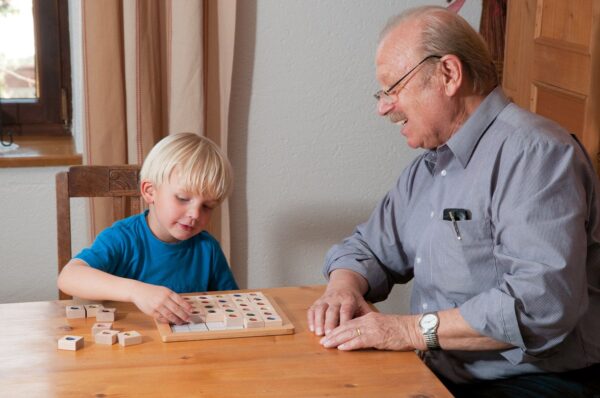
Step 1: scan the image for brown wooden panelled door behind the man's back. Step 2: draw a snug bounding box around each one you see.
[502,0,600,174]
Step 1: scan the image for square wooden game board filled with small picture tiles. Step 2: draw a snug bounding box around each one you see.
[155,291,294,343]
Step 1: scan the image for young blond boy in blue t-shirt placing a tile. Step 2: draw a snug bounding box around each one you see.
[58,133,238,324]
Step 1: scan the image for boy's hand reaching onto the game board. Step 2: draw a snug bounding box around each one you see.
[131,282,192,325]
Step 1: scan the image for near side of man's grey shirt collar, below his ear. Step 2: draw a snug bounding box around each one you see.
[446,86,510,168]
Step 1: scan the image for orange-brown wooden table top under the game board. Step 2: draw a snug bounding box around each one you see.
[0,286,451,398]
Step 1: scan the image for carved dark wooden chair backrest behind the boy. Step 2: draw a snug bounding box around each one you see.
[56,165,141,300]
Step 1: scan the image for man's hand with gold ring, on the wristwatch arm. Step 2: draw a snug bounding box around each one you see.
[320,312,424,351]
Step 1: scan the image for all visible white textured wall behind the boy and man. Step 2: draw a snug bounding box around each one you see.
[0,0,481,312]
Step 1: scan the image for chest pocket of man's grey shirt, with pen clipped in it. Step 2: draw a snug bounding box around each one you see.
[430,219,497,305]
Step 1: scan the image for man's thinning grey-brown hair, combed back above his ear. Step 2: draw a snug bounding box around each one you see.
[380,6,499,95]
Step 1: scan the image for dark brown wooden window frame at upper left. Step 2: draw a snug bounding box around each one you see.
[0,0,72,136]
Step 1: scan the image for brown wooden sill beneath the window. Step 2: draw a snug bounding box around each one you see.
[0,136,82,168]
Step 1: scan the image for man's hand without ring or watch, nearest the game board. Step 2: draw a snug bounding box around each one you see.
[307,269,373,336]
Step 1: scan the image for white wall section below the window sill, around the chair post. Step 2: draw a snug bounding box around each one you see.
[0,167,87,303]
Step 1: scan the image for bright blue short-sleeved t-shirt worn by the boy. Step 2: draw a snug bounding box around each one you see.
[75,210,238,293]
